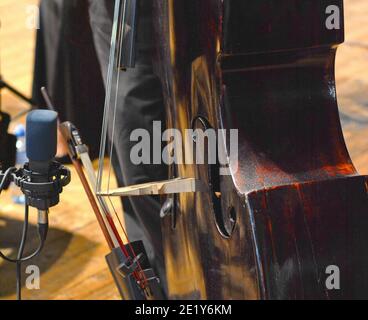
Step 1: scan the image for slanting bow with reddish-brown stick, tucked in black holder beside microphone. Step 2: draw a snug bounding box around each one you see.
[41,88,160,299]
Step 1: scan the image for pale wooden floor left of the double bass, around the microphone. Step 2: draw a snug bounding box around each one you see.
[0,0,119,299]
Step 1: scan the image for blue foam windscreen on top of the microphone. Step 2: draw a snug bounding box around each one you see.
[26,110,58,161]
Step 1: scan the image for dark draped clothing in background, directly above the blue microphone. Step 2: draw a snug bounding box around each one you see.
[33,0,105,158]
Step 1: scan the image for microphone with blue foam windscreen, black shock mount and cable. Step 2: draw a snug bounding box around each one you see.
[0,110,71,299]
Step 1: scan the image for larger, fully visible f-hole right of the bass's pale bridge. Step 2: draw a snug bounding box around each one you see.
[192,116,236,238]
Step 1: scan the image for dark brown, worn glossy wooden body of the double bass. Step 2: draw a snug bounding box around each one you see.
[154,0,368,299]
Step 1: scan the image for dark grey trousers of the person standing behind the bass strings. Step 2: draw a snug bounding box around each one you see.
[89,0,167,294]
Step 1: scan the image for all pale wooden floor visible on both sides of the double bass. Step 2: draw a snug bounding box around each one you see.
[0,0,368,299]
